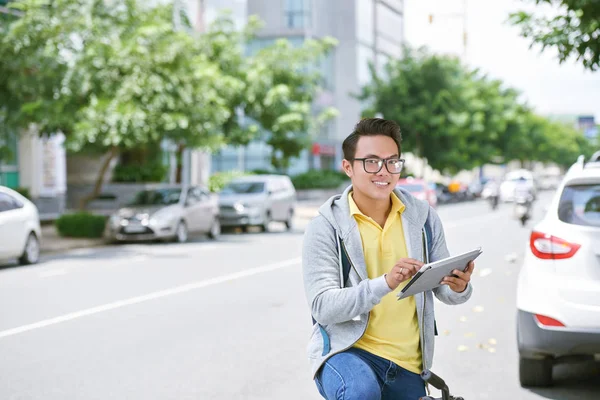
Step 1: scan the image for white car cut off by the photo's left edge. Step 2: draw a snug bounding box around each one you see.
[0,186,42,265]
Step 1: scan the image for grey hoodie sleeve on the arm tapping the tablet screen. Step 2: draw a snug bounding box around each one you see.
[302,216,392,325]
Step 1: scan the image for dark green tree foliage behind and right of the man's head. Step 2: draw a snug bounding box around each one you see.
[359,49,591,173]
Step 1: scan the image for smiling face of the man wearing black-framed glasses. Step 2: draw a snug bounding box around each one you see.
[342,135,400,200]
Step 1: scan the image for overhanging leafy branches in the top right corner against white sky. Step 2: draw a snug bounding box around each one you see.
[509,0,600,71]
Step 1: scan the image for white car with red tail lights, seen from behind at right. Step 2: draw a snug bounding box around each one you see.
[517,152,600,386]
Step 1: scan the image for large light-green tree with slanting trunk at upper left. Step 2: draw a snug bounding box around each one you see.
[0,0,234,207]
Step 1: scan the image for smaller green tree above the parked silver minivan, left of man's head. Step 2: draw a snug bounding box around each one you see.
[200,14,336,169]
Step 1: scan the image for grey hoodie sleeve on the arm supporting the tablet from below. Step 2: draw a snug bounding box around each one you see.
[428,207,473,305]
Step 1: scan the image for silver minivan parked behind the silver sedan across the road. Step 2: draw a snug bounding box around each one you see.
[219,175,296,231]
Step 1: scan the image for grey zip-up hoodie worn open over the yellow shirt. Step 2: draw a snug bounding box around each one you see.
[302,186,473,376]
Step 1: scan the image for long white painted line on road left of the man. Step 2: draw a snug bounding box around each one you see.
[0,257,302,339]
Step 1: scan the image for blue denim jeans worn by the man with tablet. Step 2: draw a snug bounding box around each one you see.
[315,348,425,400]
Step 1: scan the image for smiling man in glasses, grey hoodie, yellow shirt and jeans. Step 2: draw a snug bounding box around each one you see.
[303,118,474,400]
